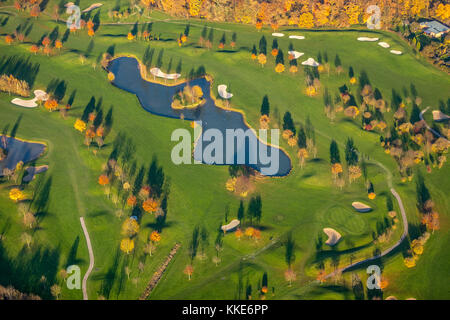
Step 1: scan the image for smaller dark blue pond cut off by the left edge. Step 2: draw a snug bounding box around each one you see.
[0,135,45,176]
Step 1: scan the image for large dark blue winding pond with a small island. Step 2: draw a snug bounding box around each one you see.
[108,57,291,176]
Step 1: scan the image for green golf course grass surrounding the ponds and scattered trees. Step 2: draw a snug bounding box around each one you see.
[0,1,450,299]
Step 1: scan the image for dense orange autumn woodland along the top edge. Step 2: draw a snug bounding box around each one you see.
[149,0,450,30]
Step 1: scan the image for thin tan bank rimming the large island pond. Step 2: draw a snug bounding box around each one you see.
[103,53,294,178]
